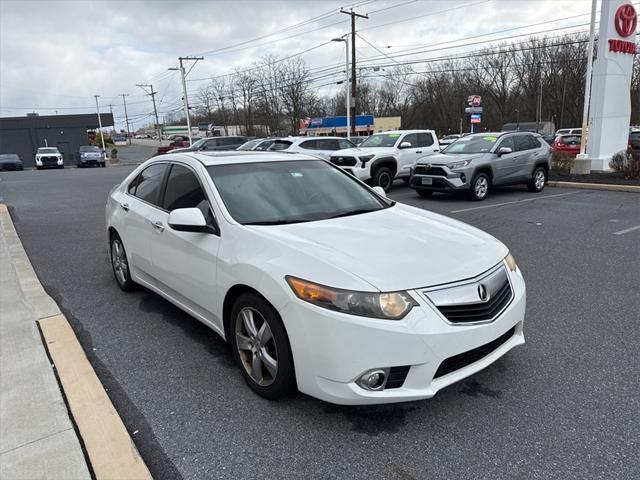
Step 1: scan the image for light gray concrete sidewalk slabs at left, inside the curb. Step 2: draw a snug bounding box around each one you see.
[0,212,91,480]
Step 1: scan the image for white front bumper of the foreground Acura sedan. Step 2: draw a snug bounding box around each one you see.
[280,264,526,405]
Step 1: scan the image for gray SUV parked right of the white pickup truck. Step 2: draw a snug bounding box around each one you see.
[409,132,551,200]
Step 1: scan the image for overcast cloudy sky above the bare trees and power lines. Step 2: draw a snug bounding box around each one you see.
[0,0,591,128]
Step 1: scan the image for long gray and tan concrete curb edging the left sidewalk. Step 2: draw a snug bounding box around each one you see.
[0,204,152,480]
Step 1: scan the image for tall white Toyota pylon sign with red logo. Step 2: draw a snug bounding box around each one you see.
[587,0,638,171]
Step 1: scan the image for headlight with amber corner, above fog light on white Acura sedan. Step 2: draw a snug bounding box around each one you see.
[285,276,418,320]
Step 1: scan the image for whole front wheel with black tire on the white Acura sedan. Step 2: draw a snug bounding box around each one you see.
[230,293,295,400]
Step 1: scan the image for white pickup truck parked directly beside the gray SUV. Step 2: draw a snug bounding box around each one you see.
[330,130,440,192]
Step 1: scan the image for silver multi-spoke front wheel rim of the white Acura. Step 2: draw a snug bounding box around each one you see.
[236,307,278,387]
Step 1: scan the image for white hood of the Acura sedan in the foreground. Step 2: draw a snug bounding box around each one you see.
[247,204,508,292]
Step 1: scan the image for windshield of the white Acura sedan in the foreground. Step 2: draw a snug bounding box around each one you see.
[207,160,395,225]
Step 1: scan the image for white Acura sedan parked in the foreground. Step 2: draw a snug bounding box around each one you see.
[106,152,525,404]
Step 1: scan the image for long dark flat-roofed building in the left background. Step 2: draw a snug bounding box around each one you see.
[0,113,113,168]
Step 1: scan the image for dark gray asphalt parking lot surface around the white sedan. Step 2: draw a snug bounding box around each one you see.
[0,167,640,479]
